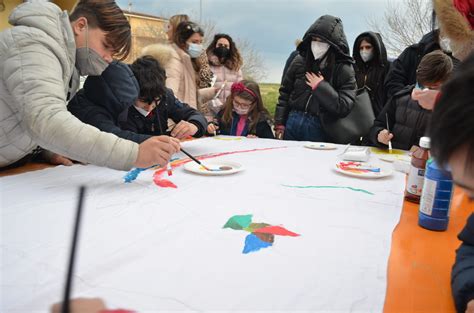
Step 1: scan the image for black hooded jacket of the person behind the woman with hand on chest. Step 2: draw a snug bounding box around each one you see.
[352,32,390,116]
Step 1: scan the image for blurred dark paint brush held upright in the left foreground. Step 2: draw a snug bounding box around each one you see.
[61,186,86,313]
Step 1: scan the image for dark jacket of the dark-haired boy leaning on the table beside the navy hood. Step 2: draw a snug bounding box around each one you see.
[118,88,207,138]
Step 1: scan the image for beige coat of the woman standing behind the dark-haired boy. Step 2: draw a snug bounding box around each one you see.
[142,44,215,114]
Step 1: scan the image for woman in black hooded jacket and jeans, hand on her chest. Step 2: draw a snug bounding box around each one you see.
[275,15,356,141]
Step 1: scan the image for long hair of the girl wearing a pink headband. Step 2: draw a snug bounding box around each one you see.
[222,80,270,132]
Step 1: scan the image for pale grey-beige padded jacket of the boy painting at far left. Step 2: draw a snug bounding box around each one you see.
[0,1,138,170]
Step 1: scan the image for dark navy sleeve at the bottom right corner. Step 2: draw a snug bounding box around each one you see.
[451,214,474,313]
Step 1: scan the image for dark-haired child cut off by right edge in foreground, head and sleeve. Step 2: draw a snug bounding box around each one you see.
[430,54,474,313]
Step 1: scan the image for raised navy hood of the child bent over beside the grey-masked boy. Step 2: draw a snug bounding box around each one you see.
[84,61,140,116]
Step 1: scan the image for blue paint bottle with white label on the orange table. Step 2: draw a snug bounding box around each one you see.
[418,159,453,231]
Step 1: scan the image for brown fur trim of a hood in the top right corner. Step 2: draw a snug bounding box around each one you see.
[433,0,474,60]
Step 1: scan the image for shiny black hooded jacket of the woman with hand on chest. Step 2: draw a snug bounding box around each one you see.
[275,15,356,125]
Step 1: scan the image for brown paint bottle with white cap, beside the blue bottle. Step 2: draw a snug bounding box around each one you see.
[405,137,430,203]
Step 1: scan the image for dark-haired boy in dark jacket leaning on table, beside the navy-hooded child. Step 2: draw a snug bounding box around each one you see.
[118,56,207,139]
